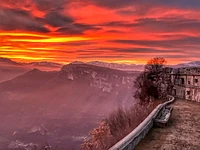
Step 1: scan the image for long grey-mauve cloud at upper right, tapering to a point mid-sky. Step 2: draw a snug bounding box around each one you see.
[100,17,200,33]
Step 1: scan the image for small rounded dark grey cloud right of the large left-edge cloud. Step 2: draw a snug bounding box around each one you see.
[45,12,74,27]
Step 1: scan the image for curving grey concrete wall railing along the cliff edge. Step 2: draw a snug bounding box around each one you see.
[109,95,175,150]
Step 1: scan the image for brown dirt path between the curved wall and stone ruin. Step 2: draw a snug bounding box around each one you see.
[135,99,200,150]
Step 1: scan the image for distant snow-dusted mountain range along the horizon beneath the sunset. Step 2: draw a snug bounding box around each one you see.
[0,58,200,82]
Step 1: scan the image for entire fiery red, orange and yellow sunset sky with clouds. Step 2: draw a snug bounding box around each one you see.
[0,0,200,64]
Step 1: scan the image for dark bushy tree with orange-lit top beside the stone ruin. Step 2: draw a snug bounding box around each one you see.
[134,57,166,104]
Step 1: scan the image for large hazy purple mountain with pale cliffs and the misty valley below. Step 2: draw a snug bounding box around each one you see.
[0,64,138,150]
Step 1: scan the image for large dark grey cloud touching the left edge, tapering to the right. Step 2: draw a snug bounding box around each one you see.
[0,9,49,32]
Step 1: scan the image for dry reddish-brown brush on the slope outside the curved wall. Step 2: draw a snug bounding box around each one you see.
[81,101,160,150]
